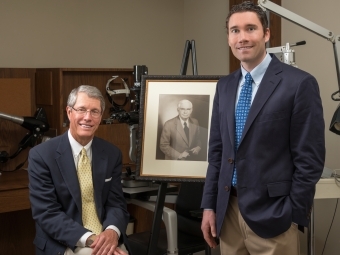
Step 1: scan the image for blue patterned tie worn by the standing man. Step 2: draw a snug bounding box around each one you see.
[232,73,253,186]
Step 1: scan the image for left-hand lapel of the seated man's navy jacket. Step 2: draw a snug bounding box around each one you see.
[55,132,82,212]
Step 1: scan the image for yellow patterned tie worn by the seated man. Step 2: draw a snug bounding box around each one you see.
[78,148,102,235]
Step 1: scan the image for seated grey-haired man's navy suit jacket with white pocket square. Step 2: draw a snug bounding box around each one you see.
[28,132,129,255]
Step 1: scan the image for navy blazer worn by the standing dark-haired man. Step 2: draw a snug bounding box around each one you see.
[202,56,325,238]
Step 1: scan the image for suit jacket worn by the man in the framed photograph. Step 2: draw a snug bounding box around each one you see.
[160,116,201,160]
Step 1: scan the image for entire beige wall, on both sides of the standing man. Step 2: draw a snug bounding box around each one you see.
[0,0,340,254]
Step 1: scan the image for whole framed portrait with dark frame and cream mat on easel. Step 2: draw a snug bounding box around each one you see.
[136,75,223,182]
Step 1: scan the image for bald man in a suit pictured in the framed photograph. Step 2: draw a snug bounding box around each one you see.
[159,99,202,160]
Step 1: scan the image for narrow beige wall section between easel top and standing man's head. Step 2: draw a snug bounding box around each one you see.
[183,0,229,75]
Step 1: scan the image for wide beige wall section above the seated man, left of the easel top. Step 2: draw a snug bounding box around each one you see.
[0,0,184,74]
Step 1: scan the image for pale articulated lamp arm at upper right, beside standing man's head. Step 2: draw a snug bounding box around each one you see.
[258,0,340,101]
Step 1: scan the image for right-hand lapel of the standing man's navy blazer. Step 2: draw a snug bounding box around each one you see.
[240,55,282,144]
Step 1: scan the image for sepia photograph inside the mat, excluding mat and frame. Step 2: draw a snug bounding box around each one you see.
[156,94,210,161]
